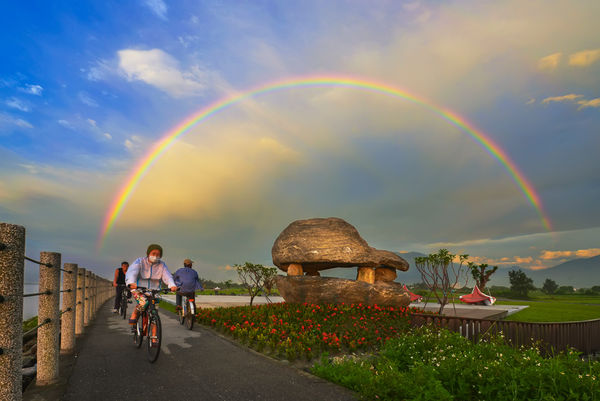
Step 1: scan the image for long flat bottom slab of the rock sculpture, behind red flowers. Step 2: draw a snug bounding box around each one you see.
[275,276,410,307]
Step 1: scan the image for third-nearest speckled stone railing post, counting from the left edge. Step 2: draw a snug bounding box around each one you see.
[60,263,77,354]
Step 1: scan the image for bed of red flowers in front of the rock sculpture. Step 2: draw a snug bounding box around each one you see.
[196,303,422,360]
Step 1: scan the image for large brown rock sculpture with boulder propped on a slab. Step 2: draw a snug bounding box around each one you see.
[271,217,410,306]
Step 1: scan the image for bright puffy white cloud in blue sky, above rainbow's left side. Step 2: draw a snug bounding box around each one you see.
[118,49,209,97]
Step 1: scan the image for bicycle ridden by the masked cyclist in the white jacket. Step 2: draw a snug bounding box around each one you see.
[133,287,166,363]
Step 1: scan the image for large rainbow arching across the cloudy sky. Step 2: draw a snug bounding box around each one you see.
[97,76,552,249]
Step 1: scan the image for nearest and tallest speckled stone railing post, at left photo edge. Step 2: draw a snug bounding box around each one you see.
[0,223,25,401]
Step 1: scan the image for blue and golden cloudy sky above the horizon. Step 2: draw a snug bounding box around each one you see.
[0,0,600,279]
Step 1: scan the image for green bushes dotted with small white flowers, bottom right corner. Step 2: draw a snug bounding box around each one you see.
[312,328,600,401]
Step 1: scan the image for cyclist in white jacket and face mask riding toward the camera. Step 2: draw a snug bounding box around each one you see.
[125,244,177,336]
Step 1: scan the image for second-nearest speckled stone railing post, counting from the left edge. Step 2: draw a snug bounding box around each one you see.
[36,252,61,386]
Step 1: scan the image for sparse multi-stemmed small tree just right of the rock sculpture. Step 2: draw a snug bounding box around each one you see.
[415,249,469,315]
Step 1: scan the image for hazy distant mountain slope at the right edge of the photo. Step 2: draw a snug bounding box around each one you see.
[525,255,600,288]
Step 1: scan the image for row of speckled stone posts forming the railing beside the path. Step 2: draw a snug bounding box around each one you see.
[0,223,114,401]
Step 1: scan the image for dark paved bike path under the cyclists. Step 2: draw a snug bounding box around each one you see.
[61,302,356,401]
